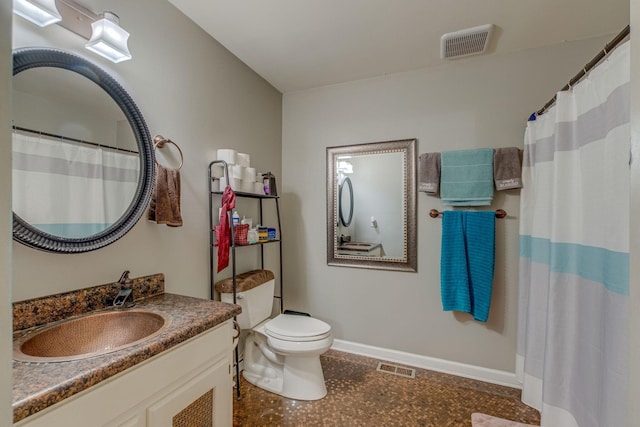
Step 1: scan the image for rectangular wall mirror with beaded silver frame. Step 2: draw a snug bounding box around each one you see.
[327,139,417,271]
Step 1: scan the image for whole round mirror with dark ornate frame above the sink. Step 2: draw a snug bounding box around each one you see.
[12,49,154,253]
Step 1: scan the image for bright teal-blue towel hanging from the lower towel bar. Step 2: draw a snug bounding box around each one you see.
[440,211,496,322]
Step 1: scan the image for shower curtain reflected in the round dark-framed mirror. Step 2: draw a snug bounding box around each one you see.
[12,132,140,238]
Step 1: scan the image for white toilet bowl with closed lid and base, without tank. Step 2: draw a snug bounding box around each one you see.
[242,314,333,400]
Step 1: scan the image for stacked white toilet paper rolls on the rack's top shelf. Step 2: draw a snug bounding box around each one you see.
[212,148,264,194]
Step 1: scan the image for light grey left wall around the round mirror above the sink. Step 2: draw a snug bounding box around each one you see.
[11,0,282,301]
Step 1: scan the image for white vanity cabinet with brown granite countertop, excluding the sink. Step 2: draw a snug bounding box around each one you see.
[13,276,241,427]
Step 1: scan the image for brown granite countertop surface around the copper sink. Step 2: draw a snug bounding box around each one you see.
[13,280,241,422]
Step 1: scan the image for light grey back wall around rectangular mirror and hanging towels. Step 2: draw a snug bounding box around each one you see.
[282,35,611,372]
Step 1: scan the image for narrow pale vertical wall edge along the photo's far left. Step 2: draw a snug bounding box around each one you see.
[0,1,13,426]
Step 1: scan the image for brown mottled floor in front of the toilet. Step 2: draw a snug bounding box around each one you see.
[233,350,540,427]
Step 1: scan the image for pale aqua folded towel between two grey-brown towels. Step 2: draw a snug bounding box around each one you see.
[440,148,493,206]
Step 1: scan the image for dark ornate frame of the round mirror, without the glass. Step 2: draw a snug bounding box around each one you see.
[13,48,154,253]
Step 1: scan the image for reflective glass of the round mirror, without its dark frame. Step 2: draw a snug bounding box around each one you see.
[12,68,140,238]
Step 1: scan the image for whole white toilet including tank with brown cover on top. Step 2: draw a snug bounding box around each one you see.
[215,270,333,400]
